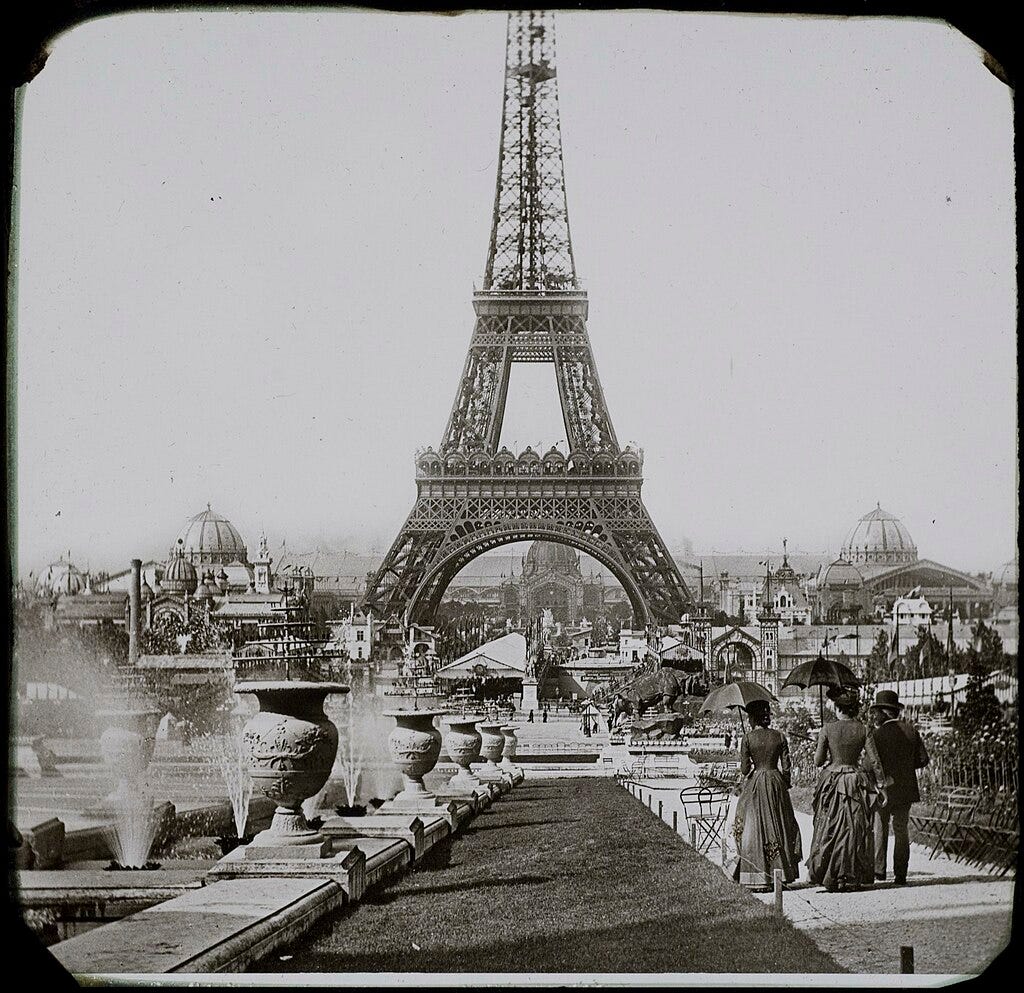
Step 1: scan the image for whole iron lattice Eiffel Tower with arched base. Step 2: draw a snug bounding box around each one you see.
[362,10,691,625]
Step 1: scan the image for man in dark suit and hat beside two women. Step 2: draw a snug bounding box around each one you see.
[867,690,928,886]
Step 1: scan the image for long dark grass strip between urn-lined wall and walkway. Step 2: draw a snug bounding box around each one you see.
[253,779,844,973]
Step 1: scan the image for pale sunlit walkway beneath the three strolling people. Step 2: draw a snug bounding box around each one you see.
[626,780,1014,976]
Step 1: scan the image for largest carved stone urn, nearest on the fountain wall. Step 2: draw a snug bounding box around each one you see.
[234,680,349,858]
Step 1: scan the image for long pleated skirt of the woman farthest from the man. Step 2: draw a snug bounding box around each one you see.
[732,769,803,890]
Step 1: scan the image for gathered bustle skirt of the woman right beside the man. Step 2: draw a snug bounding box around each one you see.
[807,766,874,891]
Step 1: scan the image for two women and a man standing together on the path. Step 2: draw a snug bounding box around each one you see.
[733,689,929,893]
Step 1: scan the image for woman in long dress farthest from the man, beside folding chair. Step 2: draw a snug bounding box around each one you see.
[732,700,803,891]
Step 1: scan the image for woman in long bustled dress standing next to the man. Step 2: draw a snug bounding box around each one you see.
[807,690,874,893]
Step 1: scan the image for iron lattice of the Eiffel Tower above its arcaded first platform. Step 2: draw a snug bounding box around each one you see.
[441,10,620,456]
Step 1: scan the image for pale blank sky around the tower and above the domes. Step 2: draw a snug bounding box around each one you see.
[16,11,1016,574]
